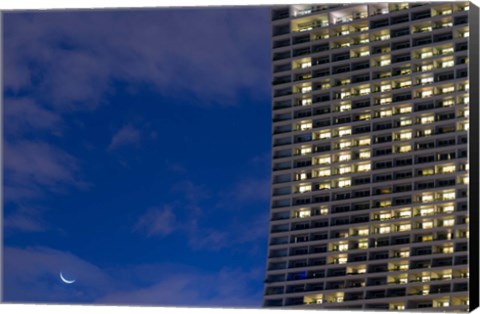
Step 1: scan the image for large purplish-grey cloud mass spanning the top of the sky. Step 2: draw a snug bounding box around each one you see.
[4,8,270,111]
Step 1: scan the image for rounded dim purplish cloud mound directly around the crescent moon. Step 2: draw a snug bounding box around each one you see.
[3,246,113,303]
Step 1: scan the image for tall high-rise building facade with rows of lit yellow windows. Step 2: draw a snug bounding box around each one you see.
[264,2,478,311]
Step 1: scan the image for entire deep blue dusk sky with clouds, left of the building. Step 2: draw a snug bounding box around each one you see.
[3,7,271,307]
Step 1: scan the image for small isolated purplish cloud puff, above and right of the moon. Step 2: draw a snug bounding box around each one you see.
[134,206,178,237]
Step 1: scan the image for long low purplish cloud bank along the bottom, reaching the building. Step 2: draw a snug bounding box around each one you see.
[4,247,263,307]
